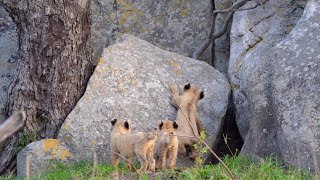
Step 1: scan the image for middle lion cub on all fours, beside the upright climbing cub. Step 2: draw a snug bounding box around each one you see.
[155,120,179,170]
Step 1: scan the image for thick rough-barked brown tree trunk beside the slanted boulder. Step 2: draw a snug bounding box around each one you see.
[0,0,94,174]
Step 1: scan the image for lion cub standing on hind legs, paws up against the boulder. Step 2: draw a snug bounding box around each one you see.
[170,83,204,156]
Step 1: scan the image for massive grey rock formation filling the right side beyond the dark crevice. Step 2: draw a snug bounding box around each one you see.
[229,0,320,172]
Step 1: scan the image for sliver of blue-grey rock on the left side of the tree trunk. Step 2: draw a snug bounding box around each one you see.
[0,6,18,123]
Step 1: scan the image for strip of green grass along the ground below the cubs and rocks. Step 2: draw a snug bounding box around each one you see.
[0,156,315,180]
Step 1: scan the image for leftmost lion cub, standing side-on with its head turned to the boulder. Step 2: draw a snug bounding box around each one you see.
[110,119,157,172]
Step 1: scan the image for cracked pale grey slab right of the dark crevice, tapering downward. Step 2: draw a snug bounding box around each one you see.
[228,0,306,138]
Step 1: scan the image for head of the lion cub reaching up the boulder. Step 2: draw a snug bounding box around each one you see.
[183,83,204,103]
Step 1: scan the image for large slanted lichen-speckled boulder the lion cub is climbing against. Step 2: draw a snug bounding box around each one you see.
[58,35,230,165]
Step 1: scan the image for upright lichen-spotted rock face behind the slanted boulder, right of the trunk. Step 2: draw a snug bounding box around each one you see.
[91,0,212,63]
